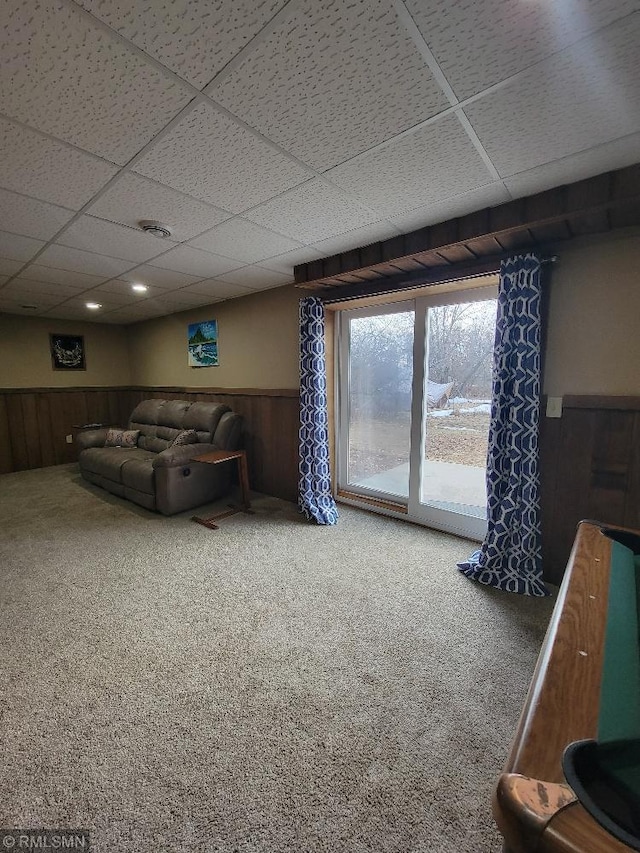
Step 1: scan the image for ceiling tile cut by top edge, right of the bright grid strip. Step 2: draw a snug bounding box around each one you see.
[405,0,638,99]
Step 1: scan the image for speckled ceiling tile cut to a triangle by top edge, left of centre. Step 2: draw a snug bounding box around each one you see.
[77,0,286,89]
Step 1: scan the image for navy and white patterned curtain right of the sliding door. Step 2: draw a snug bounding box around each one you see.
[458,254,548,595]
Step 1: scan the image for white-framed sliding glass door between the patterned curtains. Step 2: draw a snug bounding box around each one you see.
[337,287,496,538]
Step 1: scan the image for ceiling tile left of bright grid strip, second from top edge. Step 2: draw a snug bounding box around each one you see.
[328,115,492,218]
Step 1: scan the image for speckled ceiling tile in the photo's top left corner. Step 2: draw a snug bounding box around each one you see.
[0,0,193,165]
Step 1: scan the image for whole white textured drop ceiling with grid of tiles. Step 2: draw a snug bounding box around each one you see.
[0,0,640,324]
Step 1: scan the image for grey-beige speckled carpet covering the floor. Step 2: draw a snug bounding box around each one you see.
[0,465,553,853]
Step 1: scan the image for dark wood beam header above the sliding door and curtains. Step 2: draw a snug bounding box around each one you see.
[294,163,640,298]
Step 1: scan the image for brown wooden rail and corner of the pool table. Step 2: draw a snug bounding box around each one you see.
[493,521,639,853]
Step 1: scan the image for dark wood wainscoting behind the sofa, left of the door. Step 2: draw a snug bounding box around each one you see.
[0,387,300,501]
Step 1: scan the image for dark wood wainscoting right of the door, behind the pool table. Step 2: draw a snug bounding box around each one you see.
[540,396,640,583]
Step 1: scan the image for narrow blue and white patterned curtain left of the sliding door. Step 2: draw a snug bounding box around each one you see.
[298,296,338,524]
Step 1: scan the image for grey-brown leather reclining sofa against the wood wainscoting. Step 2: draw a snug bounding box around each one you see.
[77,400,242,515]
